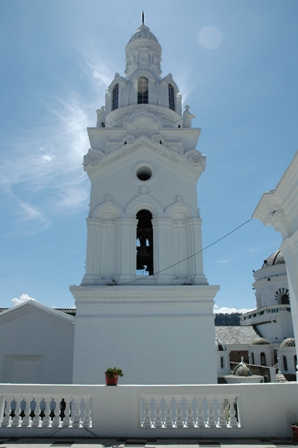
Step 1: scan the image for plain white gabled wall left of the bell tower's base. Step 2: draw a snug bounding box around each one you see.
[0,302,74,384]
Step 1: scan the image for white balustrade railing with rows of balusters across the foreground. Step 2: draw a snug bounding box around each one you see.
[0,383,298,439]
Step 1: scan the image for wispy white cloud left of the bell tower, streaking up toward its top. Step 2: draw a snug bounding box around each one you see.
[0,44,113,233]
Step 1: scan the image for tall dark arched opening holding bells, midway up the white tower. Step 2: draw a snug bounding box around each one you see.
[136,210,153,275]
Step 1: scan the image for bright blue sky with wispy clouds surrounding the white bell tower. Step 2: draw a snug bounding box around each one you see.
[0,0,298,309]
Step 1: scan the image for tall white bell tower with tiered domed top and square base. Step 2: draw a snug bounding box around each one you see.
[70,23,219,384]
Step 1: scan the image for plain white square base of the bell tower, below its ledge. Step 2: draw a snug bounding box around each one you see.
[70,285,219,384]
